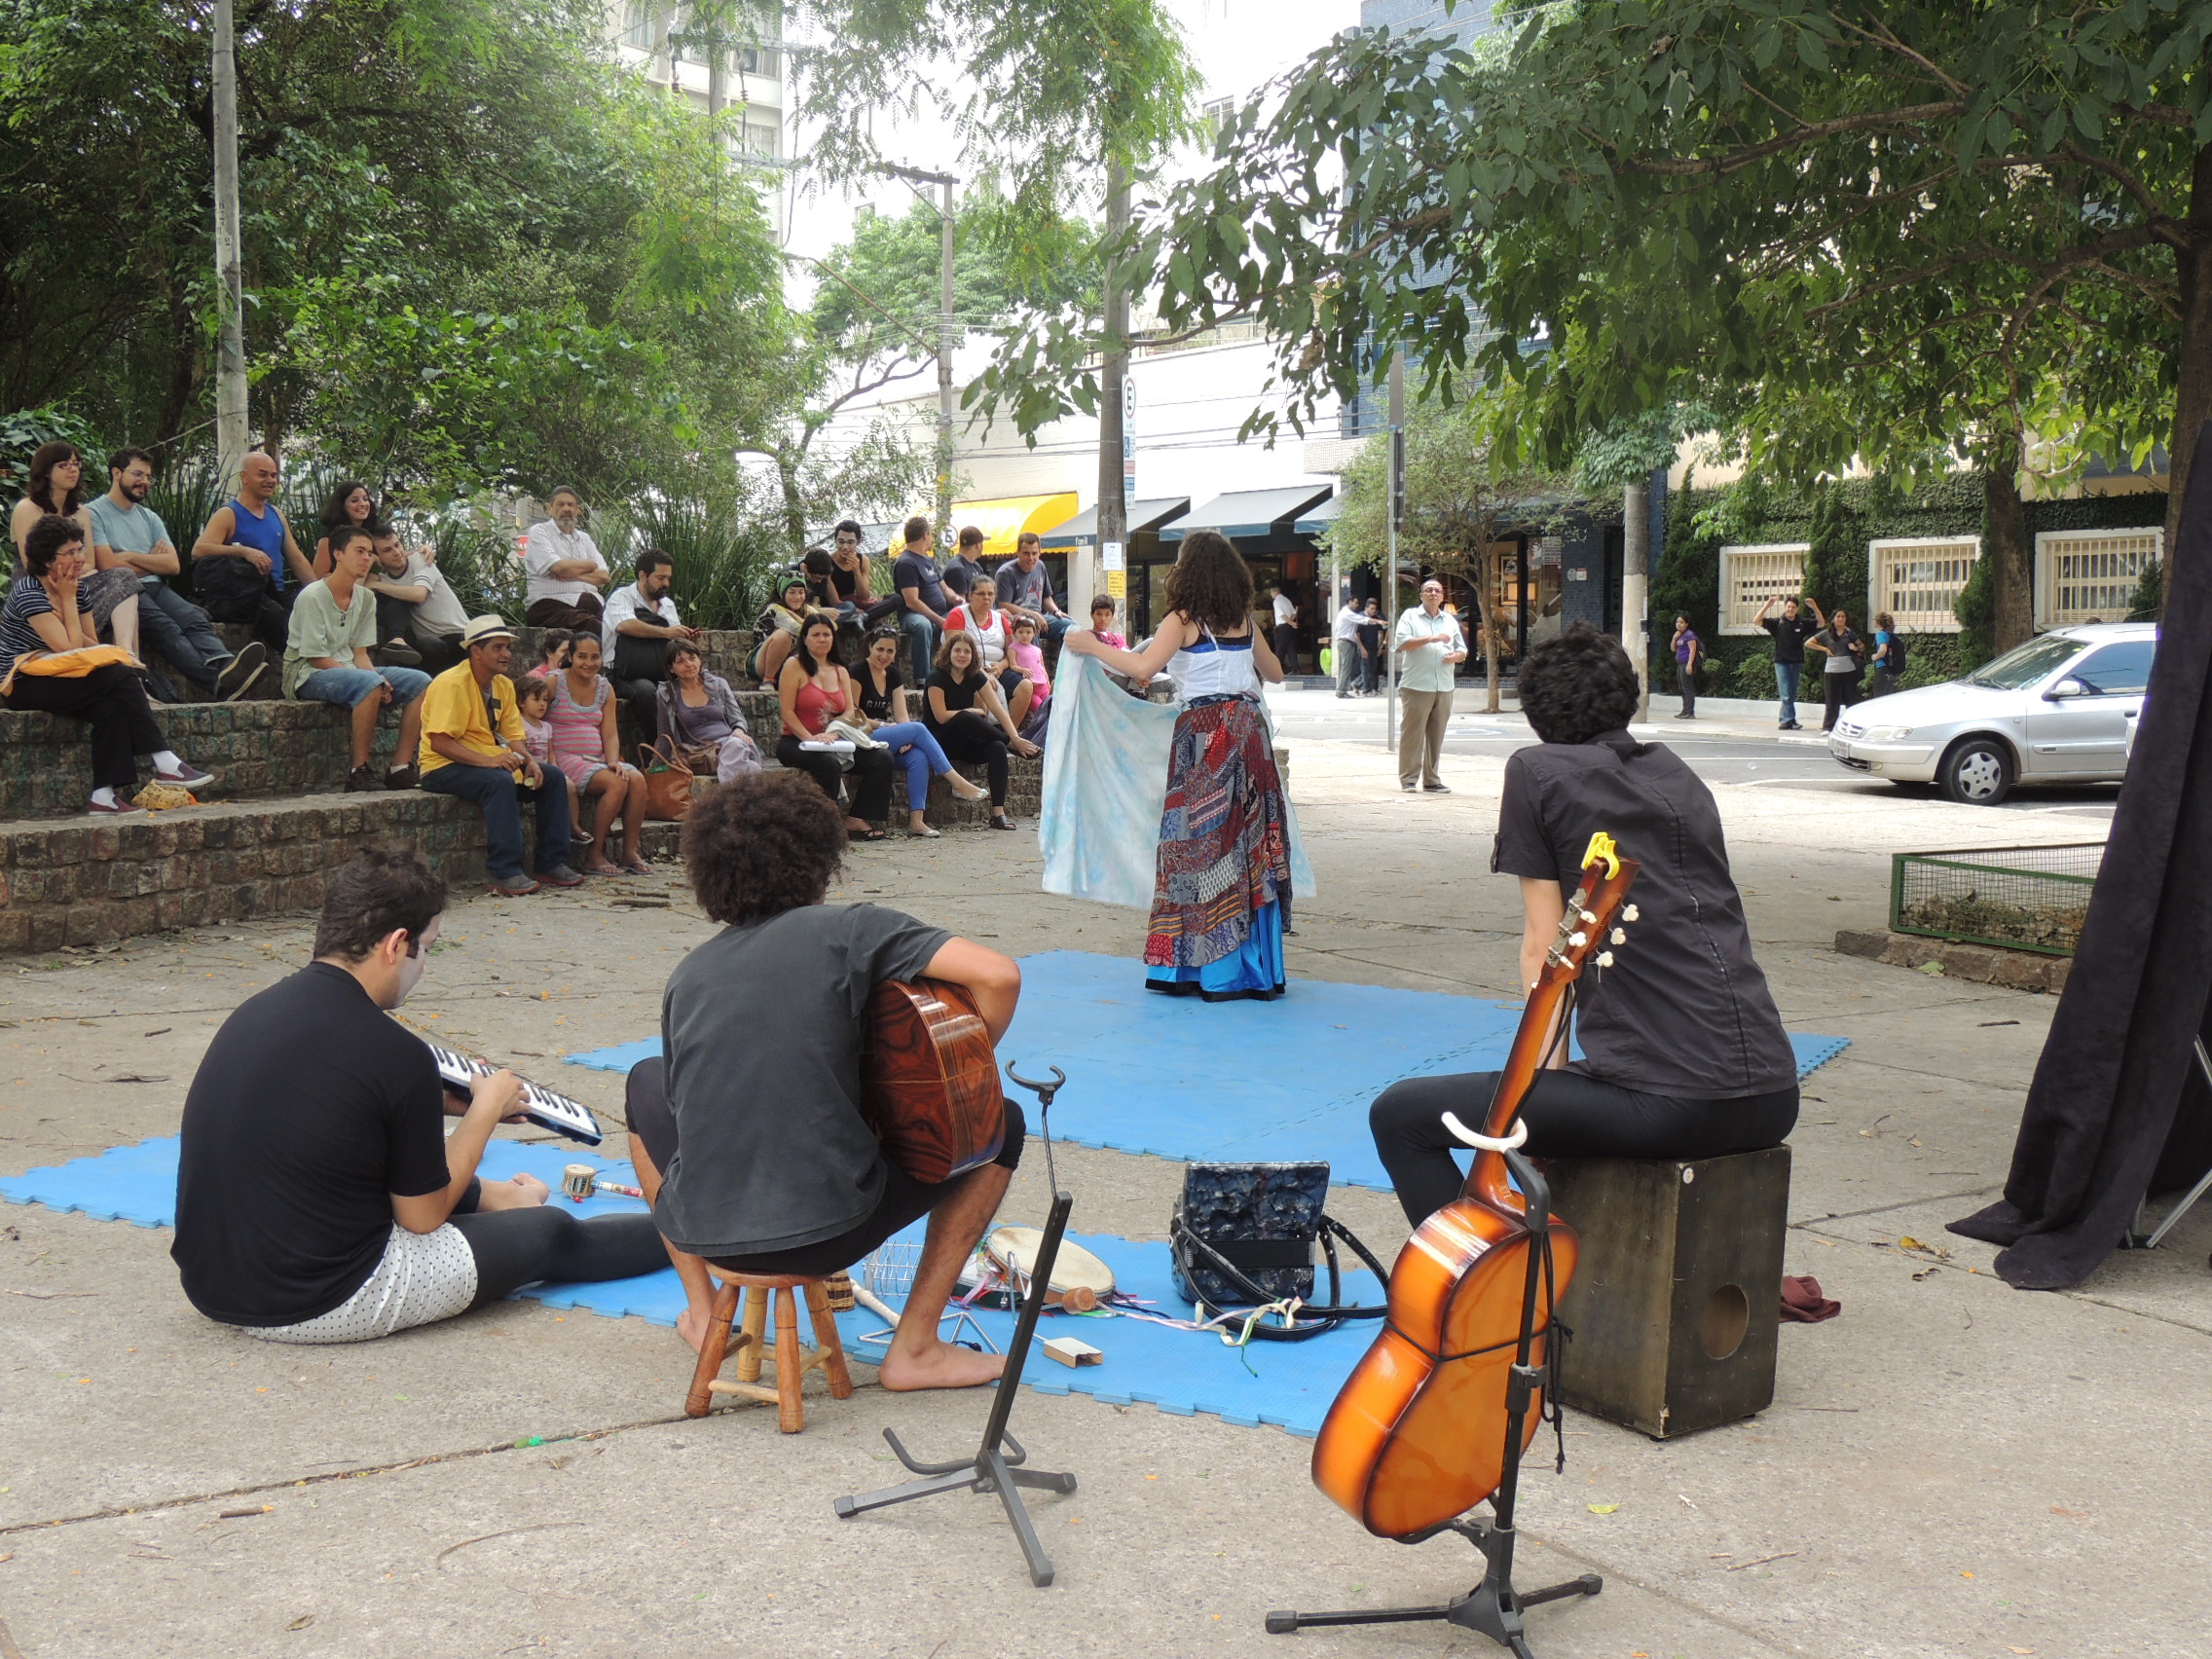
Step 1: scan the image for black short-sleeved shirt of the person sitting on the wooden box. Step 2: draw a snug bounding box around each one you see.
[1491,732,1796,1099]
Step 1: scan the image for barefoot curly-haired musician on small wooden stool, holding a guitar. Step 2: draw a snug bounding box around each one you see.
[628,772,1024,1389]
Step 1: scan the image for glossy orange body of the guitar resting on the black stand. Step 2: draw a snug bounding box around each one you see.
[1314,1198,1575,1537]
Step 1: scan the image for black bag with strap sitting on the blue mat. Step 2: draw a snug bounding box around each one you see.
[1168,1161,1389,1343]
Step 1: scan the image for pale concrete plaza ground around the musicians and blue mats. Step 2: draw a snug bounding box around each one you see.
[0,743,2212,1659]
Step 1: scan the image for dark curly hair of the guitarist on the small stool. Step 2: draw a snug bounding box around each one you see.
[683,767,845,927]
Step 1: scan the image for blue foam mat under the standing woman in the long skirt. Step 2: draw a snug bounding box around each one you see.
[569,951,1849,1193]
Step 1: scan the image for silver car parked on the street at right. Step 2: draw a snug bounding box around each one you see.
[1827,621,2158,807]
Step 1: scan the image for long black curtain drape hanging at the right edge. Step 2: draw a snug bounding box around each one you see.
[1951,423,2212,1290]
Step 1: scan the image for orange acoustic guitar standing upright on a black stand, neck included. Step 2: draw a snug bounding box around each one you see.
[1314,836,1637,1537]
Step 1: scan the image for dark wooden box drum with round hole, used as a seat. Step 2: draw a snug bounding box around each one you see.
[1546,1146,1789,1440]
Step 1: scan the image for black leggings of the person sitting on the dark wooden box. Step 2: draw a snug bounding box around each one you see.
[1367,1071,1798,1228]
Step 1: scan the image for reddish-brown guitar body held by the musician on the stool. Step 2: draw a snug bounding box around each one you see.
[861,979,1007,1186]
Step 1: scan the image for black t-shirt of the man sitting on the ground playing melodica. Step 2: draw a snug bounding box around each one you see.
[168,962,449,1325]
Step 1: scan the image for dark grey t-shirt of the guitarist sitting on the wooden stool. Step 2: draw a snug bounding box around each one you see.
[652,904,951,1256]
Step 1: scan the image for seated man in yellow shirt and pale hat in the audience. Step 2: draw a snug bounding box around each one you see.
[418,617,584,898]
